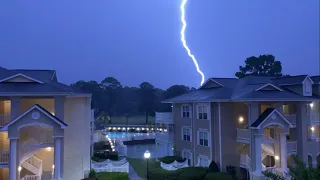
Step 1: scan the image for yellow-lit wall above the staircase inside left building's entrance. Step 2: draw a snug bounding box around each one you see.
[35,148,54,172]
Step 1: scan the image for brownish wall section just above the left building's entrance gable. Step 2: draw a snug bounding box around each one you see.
[20,98,54,114]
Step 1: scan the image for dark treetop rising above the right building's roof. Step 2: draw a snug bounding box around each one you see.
[235,55,282,78]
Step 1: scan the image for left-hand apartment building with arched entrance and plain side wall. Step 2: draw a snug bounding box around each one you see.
[0,67,92,180]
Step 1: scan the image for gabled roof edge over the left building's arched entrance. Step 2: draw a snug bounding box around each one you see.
[2,104,68,130]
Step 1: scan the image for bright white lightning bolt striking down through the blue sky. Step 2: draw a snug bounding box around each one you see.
[180,0,204,85]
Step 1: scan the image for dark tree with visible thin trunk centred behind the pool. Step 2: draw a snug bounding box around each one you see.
[139,82,155,124]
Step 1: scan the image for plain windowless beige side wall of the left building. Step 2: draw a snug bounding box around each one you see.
[63,97,91,179]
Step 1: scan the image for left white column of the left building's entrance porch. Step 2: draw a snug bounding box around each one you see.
[9,139,17,180]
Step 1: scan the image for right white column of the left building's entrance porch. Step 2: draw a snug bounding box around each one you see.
[54,137,62,180]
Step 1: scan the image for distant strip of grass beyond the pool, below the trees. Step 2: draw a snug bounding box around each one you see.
[111,115,155,125]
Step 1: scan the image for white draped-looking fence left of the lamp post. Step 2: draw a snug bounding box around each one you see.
[92,159,129,173]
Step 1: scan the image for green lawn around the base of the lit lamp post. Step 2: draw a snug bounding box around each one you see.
[127,158,162,179]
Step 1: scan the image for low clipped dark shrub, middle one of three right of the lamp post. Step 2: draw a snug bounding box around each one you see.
[179,167,208,180]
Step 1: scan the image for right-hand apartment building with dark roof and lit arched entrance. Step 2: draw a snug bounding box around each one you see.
[164,75,320,178]
